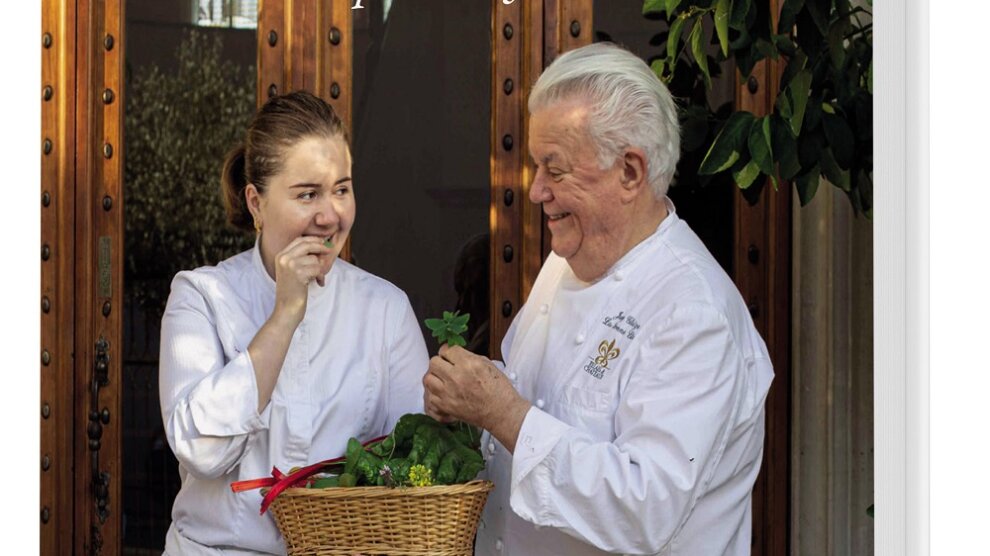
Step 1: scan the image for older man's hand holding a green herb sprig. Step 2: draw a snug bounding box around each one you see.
[423,344,530,452]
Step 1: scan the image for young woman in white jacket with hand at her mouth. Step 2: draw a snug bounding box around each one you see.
[160,92,429,555]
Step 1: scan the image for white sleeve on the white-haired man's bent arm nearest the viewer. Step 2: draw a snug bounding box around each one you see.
[510,305,746,554]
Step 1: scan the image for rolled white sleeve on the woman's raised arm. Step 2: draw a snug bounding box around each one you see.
[159,273,267,479]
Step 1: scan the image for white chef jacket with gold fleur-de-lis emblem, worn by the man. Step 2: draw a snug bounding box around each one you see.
[476,199,773,556]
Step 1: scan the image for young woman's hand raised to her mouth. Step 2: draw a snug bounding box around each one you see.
[273,236,336,325]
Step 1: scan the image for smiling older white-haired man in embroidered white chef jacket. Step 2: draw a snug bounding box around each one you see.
[423,43,773,556]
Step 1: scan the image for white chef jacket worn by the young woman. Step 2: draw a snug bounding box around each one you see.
[159,246,429,555]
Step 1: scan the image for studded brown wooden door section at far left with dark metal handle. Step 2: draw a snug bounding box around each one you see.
[40,0,123,554]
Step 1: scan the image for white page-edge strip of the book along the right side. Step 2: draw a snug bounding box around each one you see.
[873,0,930,556]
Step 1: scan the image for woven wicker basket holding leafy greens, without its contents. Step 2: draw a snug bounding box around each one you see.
[271,481,492,556]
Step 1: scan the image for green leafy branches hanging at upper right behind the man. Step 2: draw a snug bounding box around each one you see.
[643,0,873,218]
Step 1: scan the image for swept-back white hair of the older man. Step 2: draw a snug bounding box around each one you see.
[529,43,681,199]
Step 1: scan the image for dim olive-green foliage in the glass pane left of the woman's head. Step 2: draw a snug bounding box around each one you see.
[124,31,255,317]
